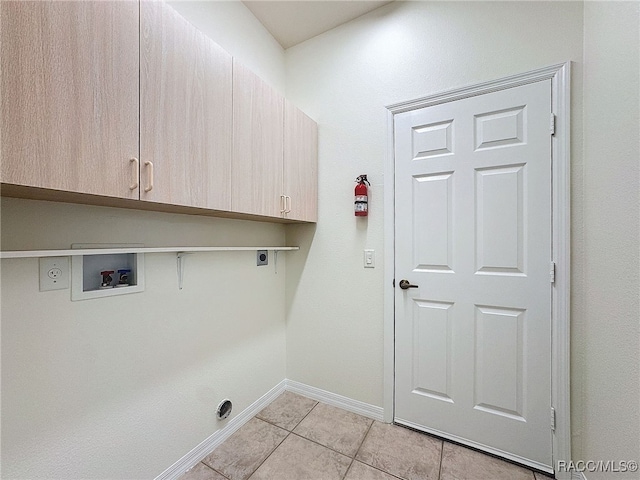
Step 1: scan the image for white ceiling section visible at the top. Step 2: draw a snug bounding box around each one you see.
[244,0,391,48]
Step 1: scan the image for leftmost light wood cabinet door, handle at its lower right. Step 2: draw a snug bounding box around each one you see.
[0,1,139,198]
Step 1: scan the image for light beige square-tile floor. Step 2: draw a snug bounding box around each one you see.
[180,392,549,480]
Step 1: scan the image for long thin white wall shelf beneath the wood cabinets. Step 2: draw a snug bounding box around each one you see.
[0,247,300,259]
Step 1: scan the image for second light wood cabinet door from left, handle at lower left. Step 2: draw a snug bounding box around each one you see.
[140,1,232,210]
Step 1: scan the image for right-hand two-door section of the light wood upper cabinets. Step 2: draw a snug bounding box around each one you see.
[232,61,318,222]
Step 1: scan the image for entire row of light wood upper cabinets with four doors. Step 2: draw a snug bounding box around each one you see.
[0,0,318,222]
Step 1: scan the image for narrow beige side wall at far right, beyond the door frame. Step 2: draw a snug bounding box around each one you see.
[572,2,640,480]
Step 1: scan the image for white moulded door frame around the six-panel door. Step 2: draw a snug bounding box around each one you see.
[384,62,571,480]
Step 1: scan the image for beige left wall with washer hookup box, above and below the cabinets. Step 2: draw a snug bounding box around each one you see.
[1,2,289,479]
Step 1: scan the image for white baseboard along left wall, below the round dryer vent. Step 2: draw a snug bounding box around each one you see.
[155,380,286,480]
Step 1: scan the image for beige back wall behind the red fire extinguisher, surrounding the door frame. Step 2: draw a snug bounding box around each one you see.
[286,2,582,412]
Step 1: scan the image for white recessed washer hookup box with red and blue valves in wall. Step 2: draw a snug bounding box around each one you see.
[71,243,144,301]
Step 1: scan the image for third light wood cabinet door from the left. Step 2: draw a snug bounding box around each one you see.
[231,60,284,217]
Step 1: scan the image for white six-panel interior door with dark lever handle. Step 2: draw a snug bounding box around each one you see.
[394,80,552,470]
